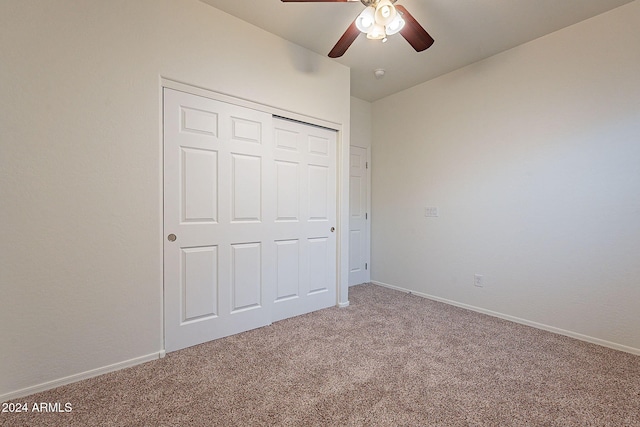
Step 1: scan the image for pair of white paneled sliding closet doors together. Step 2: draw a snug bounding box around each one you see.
[164,89,337,351]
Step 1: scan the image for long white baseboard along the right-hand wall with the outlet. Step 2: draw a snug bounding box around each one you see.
[371,280,640,356]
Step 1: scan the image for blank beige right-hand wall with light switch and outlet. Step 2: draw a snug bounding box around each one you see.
[372,1,640,354]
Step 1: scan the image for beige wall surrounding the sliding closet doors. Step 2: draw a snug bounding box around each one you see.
[0,0,350,400]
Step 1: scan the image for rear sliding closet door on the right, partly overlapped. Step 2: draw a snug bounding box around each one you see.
[273,118,337,321]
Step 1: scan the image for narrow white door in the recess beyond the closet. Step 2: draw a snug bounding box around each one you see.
[349,145,369,286]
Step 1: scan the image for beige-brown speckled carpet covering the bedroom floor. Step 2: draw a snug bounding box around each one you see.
[0,285,640,426]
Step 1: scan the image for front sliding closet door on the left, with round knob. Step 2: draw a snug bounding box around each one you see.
[164,89,275,351]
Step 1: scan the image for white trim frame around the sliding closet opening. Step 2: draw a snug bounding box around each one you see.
[159,77,350,349]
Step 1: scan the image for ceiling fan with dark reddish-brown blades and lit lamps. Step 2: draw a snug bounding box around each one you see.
[282,0,434,58]
